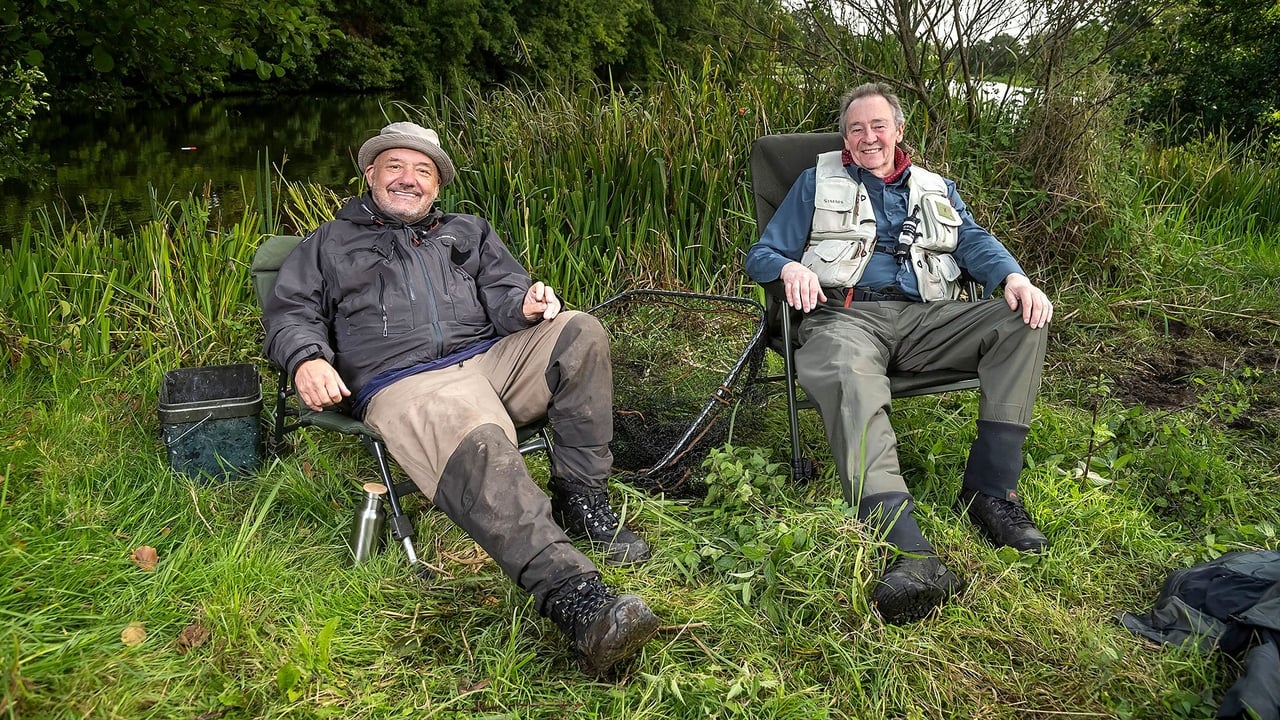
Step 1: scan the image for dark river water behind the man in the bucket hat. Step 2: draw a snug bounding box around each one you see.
[0,90,407,238]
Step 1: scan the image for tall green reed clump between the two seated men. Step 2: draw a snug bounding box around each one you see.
[283,67,835,304]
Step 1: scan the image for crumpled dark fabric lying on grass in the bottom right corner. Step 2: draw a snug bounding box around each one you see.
[1120,551,1280,720]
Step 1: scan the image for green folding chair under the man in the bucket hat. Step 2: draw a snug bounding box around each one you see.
[250,234,550,565]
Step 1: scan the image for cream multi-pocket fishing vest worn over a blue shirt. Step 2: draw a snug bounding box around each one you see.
[800,150,960,302]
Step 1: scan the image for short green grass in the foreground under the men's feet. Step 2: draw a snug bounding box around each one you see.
[0,358,1277,717]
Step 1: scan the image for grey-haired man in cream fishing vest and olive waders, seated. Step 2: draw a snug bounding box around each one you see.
[746,83,1053,623]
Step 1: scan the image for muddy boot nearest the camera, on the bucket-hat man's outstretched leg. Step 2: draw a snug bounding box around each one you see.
[547,575,658,675]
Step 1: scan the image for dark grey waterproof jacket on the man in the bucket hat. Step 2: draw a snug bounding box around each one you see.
[262,193,536,393]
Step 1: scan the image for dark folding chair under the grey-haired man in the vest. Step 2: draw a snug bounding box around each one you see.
[751,132,978,480]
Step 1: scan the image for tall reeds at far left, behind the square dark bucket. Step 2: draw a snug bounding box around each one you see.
[0,195,261,372]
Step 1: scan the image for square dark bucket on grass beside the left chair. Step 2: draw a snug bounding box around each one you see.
[159,364,262,480]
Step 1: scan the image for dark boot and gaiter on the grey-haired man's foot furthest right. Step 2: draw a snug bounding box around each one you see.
[956,420,1048,552]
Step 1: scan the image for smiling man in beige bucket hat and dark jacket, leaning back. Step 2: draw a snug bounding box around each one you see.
[264,122,658,673]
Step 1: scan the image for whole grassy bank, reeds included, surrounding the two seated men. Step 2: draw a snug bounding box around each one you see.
[0,75,1280,719]
